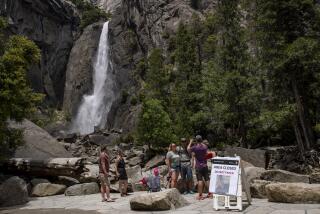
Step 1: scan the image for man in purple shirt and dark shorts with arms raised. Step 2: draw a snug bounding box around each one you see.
[187,135,211,200]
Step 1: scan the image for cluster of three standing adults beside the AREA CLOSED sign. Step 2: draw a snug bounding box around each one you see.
[166,135,215,200]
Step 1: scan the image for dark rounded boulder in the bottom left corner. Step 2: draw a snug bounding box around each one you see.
[0,176,29,207]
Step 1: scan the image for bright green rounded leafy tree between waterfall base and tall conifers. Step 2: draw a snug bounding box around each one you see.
[137,99,176,148]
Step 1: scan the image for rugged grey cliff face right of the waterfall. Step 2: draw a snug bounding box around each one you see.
[105,0,215,133]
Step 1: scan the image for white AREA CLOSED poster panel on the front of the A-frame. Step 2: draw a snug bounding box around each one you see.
[210,157,241,196]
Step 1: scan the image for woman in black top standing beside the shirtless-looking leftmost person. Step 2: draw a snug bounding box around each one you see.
[116,151,128,197]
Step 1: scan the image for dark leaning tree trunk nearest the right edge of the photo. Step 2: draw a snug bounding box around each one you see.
[292,79,314,150]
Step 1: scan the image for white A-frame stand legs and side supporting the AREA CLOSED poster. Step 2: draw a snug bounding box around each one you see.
[213,158,251,211]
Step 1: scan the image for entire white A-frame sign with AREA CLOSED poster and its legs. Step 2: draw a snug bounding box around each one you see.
[209,156,251,211]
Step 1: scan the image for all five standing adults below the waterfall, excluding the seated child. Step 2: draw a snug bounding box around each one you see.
[99,135,215,202]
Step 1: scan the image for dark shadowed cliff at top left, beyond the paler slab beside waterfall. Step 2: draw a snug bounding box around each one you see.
[0,0,80,106]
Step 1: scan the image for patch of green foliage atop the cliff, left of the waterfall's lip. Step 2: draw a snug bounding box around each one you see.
[72,0,111,29]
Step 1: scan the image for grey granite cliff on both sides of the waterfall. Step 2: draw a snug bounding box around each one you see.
[0,0,215,133]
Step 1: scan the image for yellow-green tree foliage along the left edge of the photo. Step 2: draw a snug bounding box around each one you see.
[0,36,42,159]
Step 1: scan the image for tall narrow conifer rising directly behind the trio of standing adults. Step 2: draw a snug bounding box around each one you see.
[170,16,202,137]
